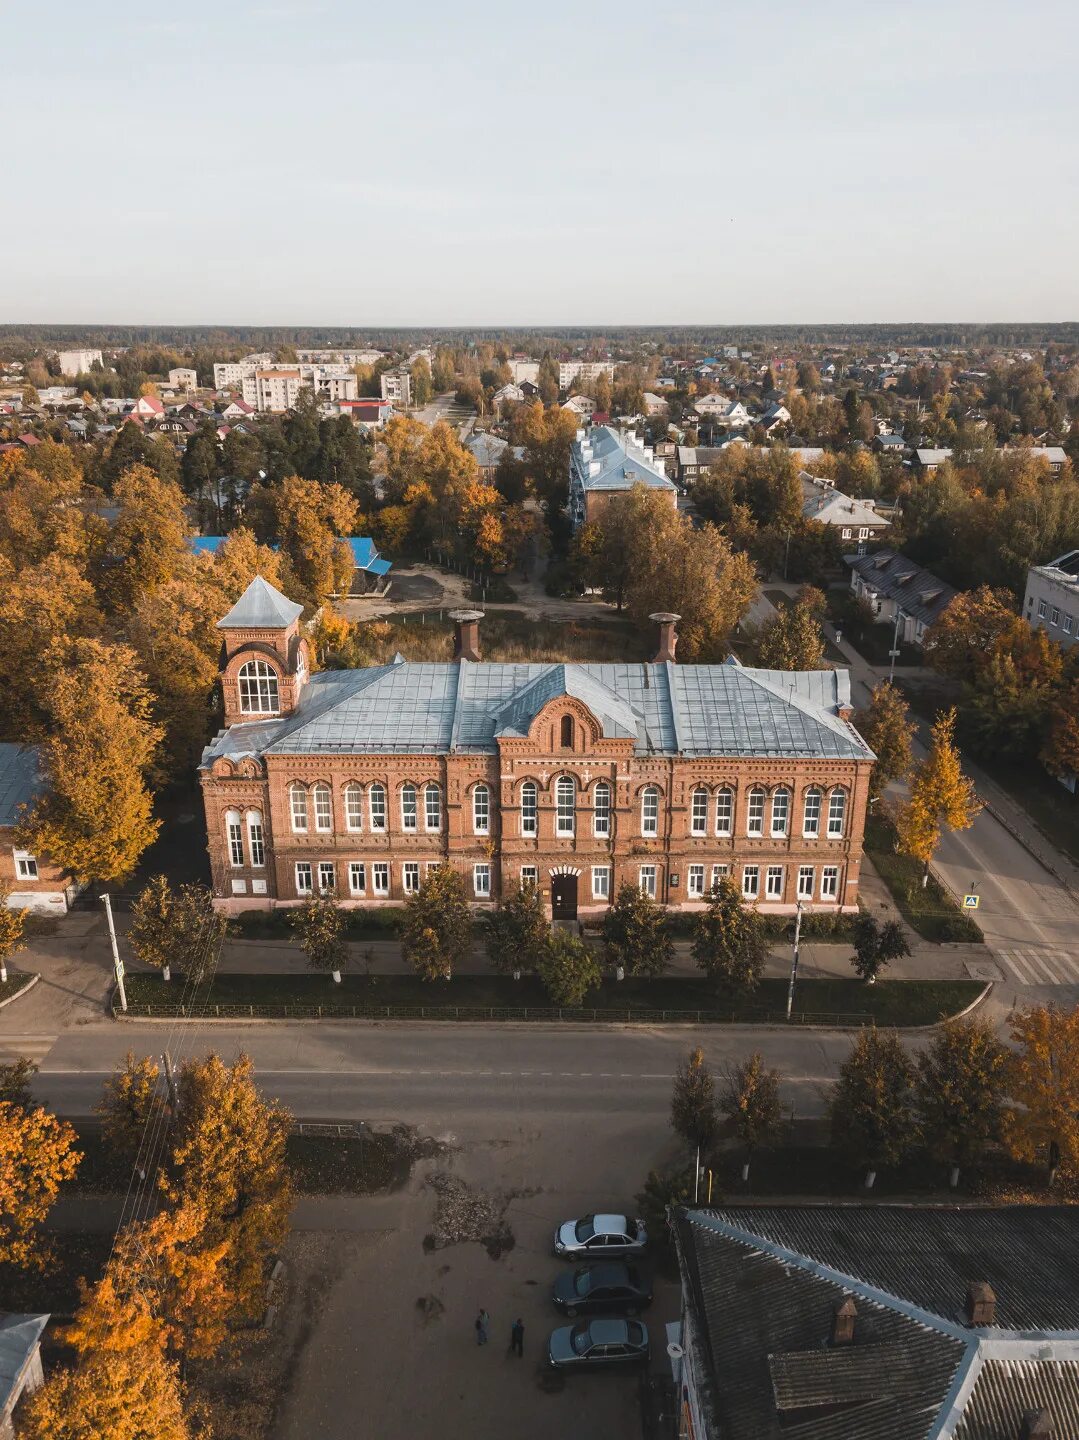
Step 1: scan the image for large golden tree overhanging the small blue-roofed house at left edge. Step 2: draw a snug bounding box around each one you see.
[16,639,161,883]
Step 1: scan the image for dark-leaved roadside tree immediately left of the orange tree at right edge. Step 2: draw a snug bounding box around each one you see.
[915,1017,1008,1188]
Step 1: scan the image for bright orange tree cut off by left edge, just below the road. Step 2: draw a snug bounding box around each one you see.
[0,1100,82,1269]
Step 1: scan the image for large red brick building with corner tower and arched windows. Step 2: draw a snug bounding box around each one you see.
[200,579,873,917]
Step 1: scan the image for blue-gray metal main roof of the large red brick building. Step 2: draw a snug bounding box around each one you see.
[203,661,872,763]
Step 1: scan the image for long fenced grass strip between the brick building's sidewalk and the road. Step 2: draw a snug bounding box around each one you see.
[127,973,981,1025]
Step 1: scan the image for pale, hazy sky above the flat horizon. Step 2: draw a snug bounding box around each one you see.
[0,0,1079,327]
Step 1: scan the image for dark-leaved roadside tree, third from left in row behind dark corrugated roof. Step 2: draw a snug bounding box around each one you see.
[828,1027,918,1189]
